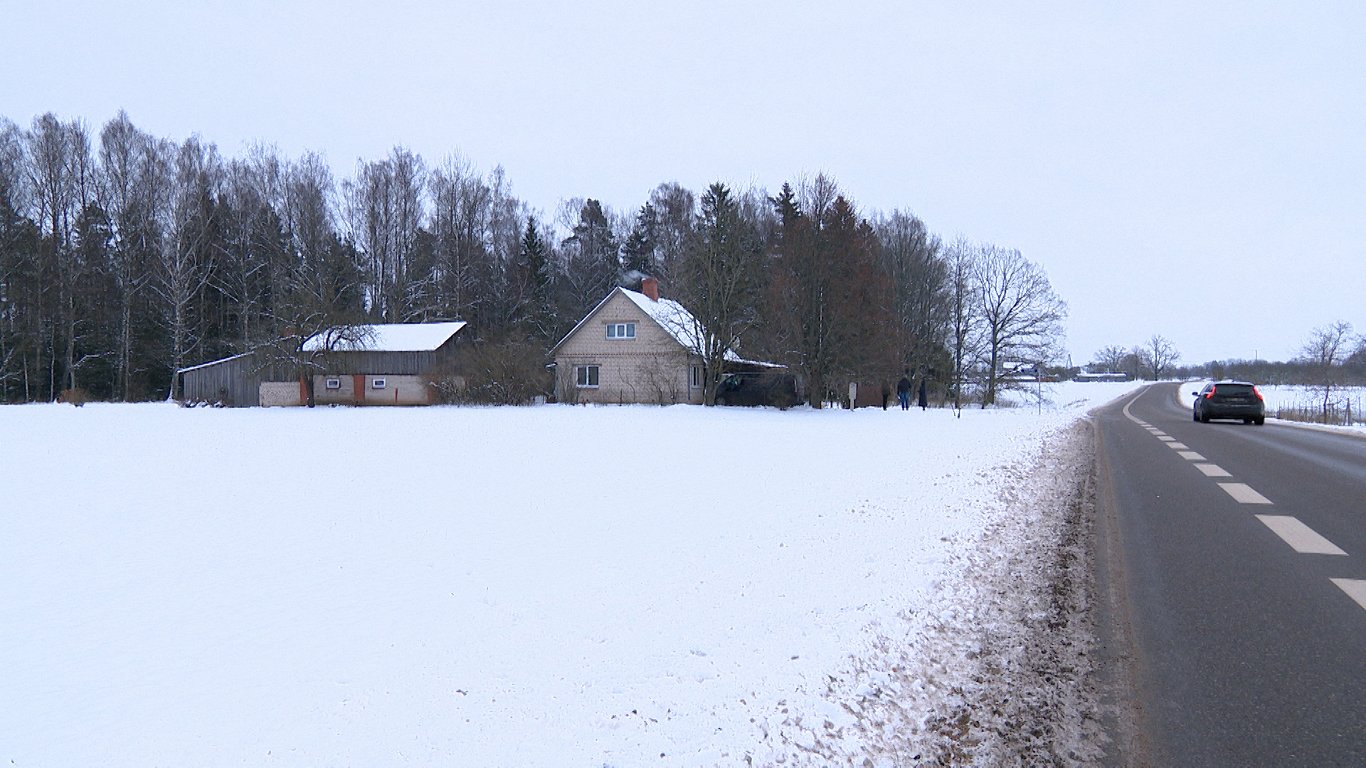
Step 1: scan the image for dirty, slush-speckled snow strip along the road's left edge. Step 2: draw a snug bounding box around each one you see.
[757,424,1108,768]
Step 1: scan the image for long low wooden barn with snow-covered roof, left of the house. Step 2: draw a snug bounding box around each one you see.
[176,323,464,406]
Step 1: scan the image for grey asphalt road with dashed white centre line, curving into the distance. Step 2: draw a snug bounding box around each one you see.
[1094,384,1366,767]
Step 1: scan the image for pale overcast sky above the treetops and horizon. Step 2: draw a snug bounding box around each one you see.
[0,0,1366,365]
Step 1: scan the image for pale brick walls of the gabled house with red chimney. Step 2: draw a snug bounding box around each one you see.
[555,292,702,404]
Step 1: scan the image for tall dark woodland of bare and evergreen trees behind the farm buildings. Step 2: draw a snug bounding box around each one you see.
[0,112,1067,406]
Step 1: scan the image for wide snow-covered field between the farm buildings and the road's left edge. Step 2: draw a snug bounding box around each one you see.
[0,384,1137,768]
